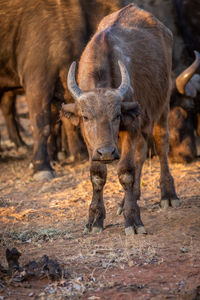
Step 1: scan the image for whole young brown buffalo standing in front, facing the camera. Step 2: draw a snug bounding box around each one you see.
[62,4,179,234]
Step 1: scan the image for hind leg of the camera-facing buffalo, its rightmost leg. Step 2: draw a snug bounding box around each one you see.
[153,110,179,209]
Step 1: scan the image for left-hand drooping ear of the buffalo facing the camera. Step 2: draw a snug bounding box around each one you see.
[60,103,79,126]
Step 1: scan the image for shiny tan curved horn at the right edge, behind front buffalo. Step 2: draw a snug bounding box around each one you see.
[176,51,200,95]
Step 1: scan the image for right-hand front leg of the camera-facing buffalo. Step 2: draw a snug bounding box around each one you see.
[118,132,146,235]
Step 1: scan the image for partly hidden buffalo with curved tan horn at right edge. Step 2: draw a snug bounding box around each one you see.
[169,51,200,163]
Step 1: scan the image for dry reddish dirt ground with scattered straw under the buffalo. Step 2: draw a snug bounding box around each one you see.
[0,101,200,300]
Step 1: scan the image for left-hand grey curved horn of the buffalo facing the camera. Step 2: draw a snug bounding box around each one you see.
[67,61,82,100]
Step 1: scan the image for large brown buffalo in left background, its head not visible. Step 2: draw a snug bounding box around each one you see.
[0,0,133,179]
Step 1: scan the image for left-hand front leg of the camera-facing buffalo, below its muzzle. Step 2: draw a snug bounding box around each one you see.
[84,162,107,233]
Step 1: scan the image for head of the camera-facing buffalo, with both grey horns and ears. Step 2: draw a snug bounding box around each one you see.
[62,61,140,163]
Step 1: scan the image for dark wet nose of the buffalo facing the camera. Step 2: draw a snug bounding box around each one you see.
[93,147,119,161]
